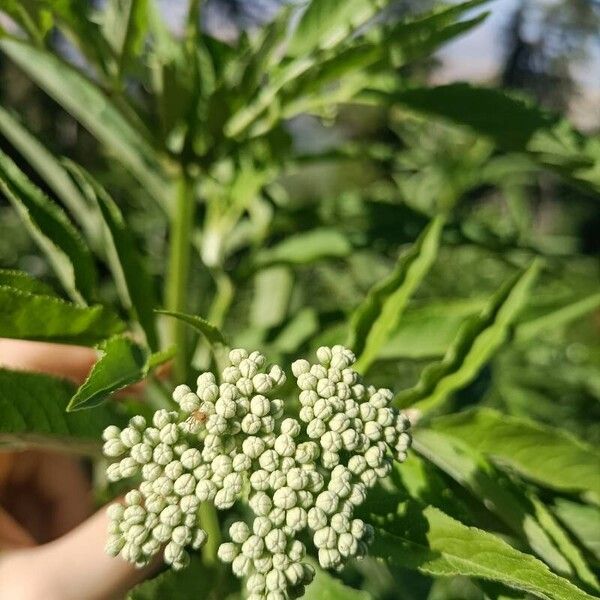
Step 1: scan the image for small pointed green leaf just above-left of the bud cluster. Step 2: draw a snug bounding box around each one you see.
[67,336,174,411]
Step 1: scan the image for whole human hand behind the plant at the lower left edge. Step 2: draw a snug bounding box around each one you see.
[0,340,159,600]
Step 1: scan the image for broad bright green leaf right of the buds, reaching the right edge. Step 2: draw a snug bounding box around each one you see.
[433,408,600,496]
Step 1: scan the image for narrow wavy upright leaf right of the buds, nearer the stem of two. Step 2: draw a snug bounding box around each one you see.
[347,217,444,372]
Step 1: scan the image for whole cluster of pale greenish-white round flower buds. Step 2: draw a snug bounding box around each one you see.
[104,346,410,600]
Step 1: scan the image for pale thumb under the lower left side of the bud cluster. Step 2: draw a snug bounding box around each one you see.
[2,508,159,600]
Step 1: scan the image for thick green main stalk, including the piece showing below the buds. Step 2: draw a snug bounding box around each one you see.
[166,172,221,564]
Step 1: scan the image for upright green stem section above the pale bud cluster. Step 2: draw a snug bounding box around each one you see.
[165,173,195,383]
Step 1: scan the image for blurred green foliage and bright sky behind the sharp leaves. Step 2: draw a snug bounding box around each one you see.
[0,0,600,600]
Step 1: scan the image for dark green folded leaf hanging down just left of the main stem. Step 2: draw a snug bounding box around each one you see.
[68,163,158,350]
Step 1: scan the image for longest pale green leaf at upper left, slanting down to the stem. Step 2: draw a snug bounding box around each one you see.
[0,38,169,206]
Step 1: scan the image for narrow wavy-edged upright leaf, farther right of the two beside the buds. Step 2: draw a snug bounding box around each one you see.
[396,260,541,410]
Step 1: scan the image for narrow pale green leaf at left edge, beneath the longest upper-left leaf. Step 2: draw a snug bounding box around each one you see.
[0,106,96,235]
